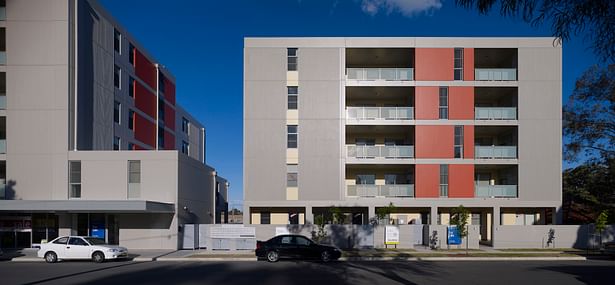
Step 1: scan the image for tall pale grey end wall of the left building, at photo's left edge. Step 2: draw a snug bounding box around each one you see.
[5,0,70,200]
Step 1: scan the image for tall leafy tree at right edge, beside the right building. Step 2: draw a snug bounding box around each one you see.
[563,65,615,161]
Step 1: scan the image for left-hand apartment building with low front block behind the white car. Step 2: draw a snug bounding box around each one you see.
[0,0,228,249]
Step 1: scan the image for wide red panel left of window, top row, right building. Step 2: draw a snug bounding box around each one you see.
[414,48,455,81]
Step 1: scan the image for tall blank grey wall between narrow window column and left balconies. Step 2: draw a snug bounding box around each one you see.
[300,48,345,201]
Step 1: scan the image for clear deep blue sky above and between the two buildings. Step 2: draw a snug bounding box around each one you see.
[99,0,597,209]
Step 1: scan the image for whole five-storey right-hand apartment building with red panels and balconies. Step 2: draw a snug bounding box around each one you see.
[244,37,562,242]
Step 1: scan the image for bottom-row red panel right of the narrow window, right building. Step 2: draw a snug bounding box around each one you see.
[448,164,474,198]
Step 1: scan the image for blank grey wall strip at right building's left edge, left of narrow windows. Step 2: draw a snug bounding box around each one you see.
[243,47,286,201]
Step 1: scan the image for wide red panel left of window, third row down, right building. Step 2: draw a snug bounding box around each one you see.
[415,126,455,158]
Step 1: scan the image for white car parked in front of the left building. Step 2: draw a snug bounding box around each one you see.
[38,236,128,263]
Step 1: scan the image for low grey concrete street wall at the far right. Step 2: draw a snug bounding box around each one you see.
[493,225,615,249]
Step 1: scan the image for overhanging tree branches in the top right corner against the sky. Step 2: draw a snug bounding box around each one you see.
[455,0,615,62]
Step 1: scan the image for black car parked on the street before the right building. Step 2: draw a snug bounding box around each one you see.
[256,235,342,262]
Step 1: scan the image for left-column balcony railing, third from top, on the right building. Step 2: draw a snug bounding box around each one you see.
[346,145,414,159]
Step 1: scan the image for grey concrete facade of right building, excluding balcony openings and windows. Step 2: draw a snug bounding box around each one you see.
[244,37,562,243]
